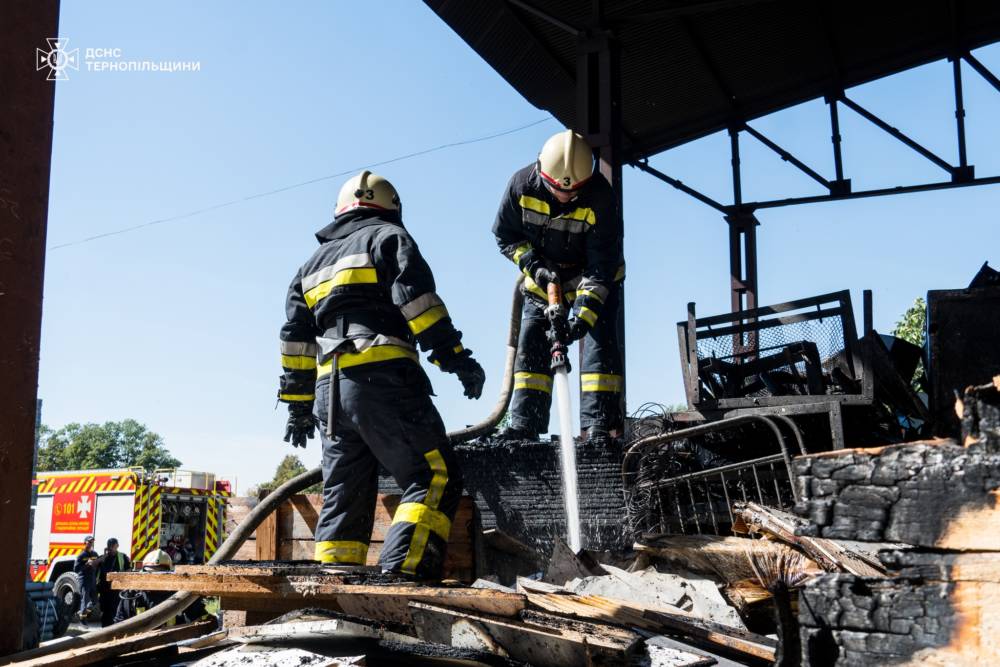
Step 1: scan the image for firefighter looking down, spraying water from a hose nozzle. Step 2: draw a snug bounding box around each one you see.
[493,130,625,446]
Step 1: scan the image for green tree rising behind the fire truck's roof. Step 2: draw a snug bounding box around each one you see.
[38,419,181,471]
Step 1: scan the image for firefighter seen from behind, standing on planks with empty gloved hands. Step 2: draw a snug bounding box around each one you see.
[278,171,485,579]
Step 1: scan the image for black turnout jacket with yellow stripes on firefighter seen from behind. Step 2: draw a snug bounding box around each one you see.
[278,210,470,403]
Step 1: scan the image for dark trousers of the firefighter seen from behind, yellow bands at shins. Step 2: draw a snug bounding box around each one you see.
[315,360,462,579]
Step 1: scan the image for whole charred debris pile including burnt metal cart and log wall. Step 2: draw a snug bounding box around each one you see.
[9,266,1000,667]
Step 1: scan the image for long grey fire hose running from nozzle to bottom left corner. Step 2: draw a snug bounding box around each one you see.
[0,275,524,664]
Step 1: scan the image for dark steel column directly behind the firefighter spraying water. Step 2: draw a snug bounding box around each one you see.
[576,7,625,430]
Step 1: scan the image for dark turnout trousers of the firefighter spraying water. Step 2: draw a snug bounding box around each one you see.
[510,282,624,433]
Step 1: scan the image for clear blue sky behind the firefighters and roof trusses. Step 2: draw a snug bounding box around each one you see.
[39,0,1000,490]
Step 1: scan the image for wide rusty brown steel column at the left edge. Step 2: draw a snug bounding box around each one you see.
[0,0,59,655]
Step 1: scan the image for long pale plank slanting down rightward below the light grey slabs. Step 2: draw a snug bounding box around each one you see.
[527,593,775,662]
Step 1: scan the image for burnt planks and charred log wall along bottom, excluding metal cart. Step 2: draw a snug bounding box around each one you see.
[13,379,1000,667]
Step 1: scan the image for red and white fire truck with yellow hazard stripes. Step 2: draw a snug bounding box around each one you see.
[29,468,232,609]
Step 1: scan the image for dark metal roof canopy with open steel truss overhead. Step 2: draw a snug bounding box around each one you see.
[425,0,1000,311]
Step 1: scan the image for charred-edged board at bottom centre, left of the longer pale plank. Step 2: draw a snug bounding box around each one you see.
[410,602,638,667]
